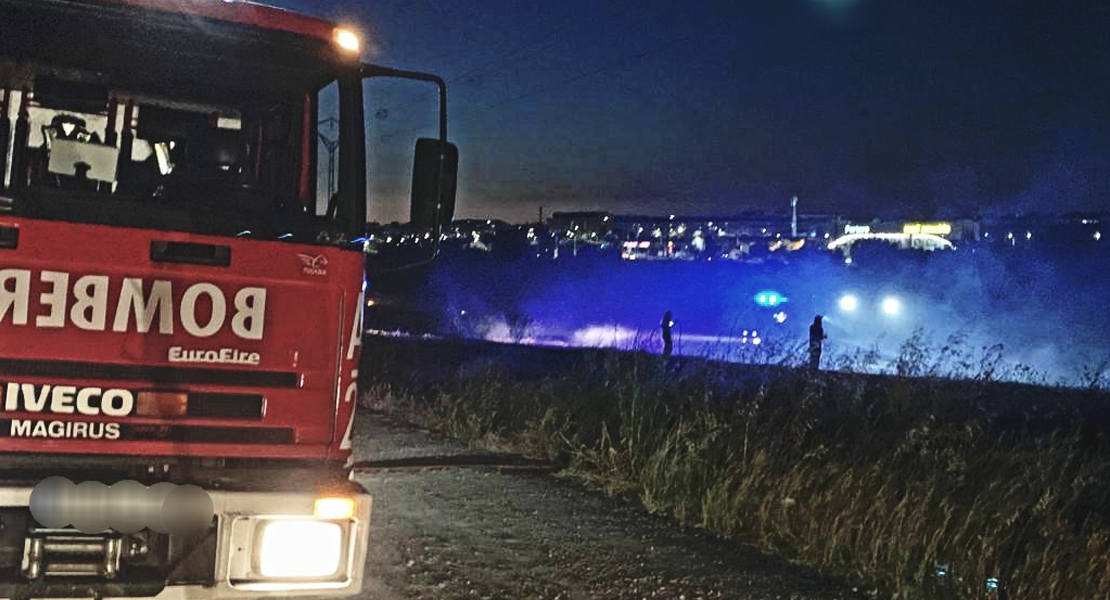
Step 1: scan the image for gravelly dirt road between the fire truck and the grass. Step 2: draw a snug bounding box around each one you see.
[346,414,865,600]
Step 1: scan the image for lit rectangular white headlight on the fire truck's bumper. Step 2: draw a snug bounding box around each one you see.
[258,520,344,579]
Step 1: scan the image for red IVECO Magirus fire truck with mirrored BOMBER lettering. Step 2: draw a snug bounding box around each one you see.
[0,0,457,599]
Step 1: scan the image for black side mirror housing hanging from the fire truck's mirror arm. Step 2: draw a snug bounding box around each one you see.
[411,138,458,230]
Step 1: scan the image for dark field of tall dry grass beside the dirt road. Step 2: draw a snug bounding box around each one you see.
[362,338,1110,600]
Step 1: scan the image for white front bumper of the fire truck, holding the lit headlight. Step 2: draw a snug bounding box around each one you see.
[0,484,372,600]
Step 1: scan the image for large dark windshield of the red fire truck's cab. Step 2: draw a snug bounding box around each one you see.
[0,1,364,243]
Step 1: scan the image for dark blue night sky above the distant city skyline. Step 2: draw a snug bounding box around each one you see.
[270,0,1110,222]
